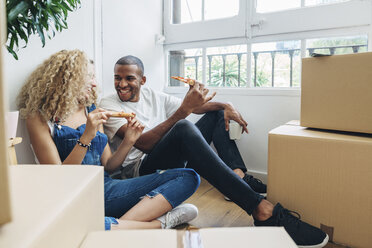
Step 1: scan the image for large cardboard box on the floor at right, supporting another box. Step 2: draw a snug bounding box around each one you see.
[268,125,372,247]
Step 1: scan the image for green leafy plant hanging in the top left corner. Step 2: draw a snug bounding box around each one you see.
[6,0,81,59]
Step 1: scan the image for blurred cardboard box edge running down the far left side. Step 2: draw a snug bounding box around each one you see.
[0,0,11,225]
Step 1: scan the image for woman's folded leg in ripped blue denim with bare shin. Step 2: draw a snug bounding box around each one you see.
[105,169,200,222]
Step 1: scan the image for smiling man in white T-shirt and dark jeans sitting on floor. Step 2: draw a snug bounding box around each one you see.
[101,56,328,247]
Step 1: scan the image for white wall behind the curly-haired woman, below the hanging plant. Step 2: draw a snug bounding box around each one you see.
[4,1,94,164]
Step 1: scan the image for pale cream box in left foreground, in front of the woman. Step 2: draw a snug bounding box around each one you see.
[0,165,104,248]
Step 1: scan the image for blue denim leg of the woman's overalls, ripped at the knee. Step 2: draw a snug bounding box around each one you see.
[104,168,200,218]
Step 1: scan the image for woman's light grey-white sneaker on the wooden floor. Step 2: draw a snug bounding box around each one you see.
[157,203,198,229]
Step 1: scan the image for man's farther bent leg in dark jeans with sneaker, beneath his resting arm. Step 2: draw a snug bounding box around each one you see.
[195,110,266,194]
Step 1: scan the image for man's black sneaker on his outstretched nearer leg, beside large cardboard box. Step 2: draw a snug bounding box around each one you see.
[254,203,328,248]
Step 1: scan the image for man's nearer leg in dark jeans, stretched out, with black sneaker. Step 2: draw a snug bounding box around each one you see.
[140,120,328,247]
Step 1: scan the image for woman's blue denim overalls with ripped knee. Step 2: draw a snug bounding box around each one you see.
[53,105,200,230]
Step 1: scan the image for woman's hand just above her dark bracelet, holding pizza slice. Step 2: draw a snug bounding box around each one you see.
[80,108,108,144]
